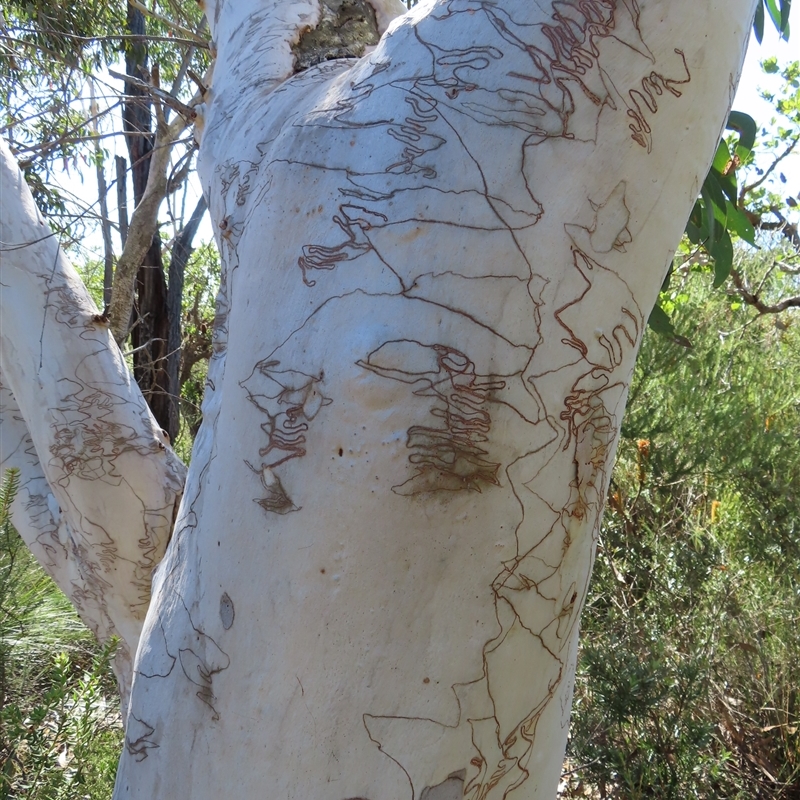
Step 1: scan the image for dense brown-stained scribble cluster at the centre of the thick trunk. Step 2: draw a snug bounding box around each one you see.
[358,339,505,495]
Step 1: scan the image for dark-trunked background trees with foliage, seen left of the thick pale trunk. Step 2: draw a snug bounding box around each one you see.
[0,0,208,440]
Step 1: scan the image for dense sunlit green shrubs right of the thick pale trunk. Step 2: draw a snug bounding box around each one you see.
[565,248,800,800]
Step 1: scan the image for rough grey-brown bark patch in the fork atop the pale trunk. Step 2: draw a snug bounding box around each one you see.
[292,0,380,73]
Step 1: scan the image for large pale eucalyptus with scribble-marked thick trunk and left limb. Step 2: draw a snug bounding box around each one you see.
[0,0,788,800]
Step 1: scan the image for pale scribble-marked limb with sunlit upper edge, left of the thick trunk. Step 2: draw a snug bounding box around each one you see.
[0,143,185,705]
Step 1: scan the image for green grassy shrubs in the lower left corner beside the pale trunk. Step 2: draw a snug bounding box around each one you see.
[0,470,122,800]
